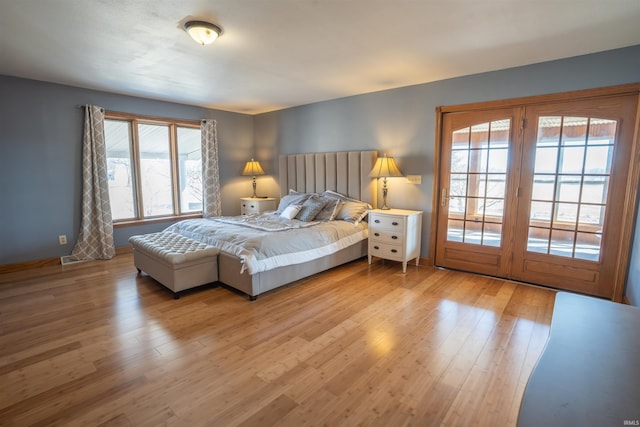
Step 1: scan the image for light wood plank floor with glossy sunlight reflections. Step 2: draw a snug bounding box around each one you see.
[0,254,555,426]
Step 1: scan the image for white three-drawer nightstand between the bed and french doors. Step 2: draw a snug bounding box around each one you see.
[368,209,422,273]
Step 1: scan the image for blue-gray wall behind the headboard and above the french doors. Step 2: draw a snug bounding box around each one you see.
[254,45,640,304]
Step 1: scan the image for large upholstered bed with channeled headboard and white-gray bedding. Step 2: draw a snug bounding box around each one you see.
[166,151,377,300]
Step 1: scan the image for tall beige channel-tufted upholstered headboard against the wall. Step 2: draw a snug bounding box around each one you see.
[278,151,378,208]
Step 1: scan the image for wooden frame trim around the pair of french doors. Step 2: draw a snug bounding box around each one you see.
[429,83,640,302]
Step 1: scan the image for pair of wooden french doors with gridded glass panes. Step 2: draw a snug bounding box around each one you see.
[434,94,638,298]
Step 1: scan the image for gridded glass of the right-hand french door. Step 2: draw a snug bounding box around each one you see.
[527,116,617,261]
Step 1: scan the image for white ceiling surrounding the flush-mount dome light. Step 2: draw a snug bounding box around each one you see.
[0,0,640,114]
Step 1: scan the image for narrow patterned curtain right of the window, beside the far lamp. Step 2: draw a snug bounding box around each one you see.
[200,120,222,218]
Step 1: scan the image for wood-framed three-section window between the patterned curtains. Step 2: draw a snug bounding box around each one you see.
[104,113,202,222]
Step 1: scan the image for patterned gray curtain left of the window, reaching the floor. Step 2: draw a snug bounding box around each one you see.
[71,105,115,260]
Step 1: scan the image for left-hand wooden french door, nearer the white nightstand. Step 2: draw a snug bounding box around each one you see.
[436,108,523,277]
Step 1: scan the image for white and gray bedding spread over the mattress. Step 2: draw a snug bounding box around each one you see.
[165,213,368,274]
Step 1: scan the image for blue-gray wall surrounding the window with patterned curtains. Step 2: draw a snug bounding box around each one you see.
[0,76,253,265]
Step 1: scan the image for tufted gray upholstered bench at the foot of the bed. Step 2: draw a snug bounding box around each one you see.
[129,232,220,299]
